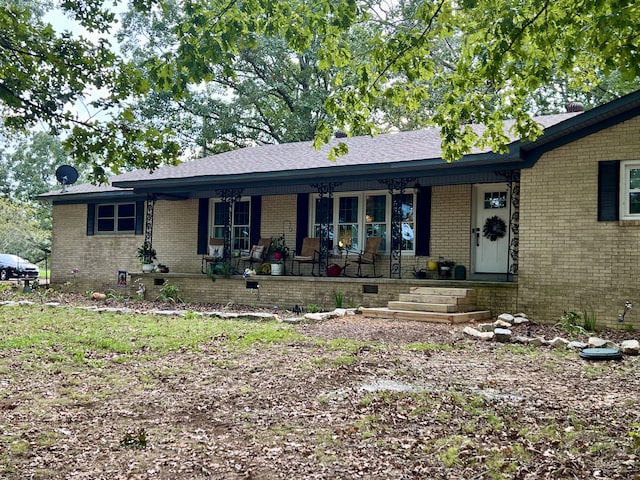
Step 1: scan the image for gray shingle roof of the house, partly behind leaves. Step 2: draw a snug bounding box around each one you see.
[39,113,592,200]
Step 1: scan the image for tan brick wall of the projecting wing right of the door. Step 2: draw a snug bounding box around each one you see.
[518,114,640,327]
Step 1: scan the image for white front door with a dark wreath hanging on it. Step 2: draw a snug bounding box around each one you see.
[471,183,511,273]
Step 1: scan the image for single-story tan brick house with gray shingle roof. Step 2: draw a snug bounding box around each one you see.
[40,91,640,325]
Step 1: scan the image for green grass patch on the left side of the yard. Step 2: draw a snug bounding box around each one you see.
[0,306,303,360]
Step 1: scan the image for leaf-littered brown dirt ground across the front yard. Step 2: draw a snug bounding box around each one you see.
[0,298,640,480]
